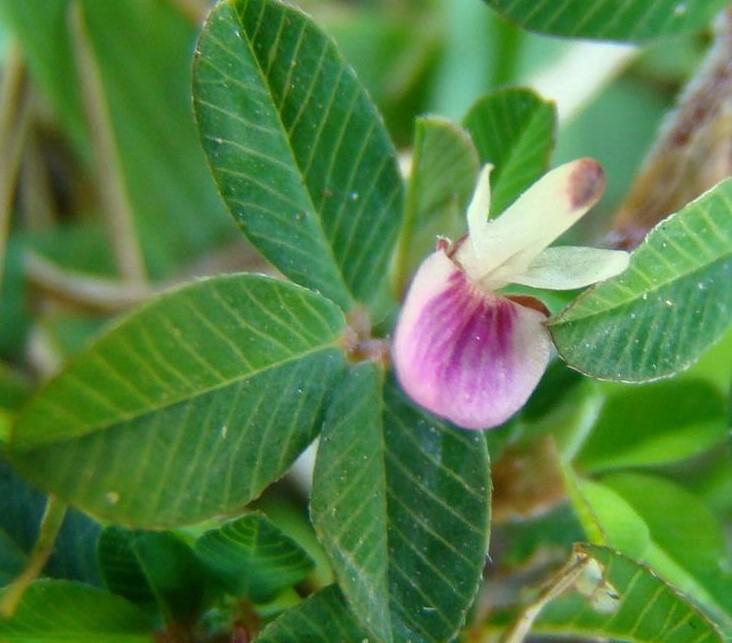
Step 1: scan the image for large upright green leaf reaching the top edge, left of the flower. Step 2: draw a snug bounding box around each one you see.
[194,0,402,308]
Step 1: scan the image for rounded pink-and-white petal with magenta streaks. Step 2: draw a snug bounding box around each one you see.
[392,250,551,429]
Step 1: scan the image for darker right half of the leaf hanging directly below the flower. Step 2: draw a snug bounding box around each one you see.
[384,379,491,641]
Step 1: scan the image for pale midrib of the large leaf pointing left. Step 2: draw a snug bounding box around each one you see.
[10,339,337,452]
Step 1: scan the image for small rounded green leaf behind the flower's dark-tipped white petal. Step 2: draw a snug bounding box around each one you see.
[463,87,557,216]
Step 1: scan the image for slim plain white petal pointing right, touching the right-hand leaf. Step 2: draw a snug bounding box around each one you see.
[511,246,630,290]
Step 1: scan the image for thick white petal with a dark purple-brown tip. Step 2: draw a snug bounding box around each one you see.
[457,158,605,288]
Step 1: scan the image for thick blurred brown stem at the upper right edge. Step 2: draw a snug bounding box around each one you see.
[610,8,732,249]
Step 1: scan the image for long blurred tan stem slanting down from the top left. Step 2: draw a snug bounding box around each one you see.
[68,1,146,284]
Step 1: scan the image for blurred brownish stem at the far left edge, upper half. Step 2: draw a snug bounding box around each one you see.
[0,43,29,284]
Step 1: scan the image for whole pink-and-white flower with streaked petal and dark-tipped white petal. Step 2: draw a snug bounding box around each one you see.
[392,159,629,429]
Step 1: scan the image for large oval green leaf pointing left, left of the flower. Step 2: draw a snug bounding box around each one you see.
[11,275,344,527]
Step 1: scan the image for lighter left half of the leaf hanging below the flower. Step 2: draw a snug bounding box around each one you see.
[310,362,392,641]
